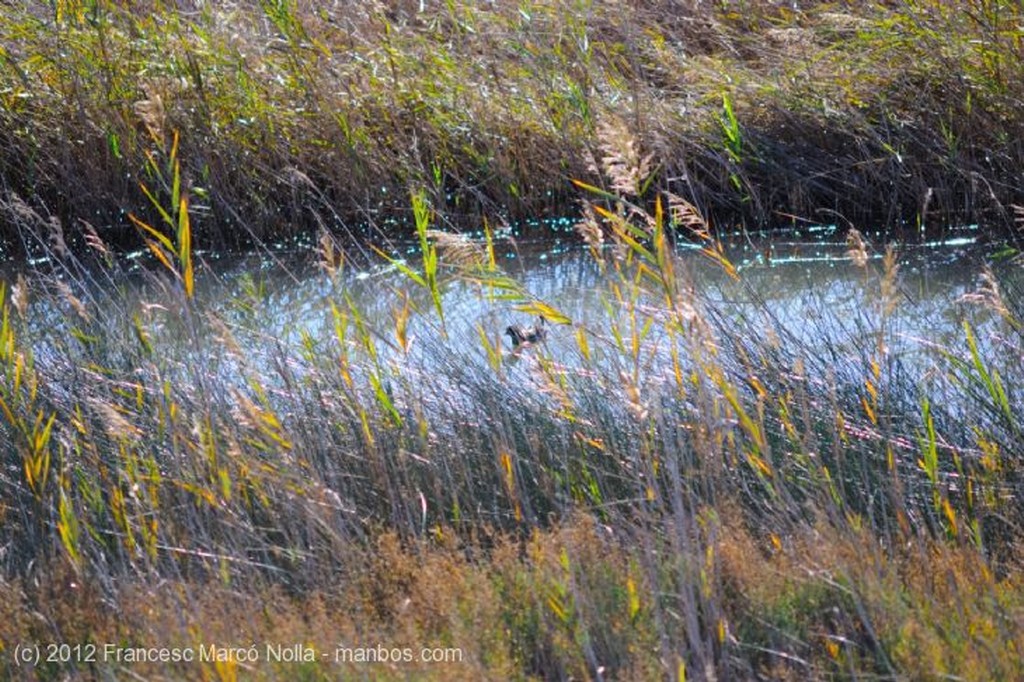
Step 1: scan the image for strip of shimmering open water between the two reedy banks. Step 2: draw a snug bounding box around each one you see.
[8,228,1015,401]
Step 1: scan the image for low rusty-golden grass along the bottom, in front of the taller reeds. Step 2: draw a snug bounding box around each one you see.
[0,518,1024,680]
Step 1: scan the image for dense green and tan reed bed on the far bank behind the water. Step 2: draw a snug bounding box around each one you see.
[0,0,1024,248]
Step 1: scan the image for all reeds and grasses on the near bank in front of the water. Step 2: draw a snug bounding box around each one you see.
[0,119,1024,680]
